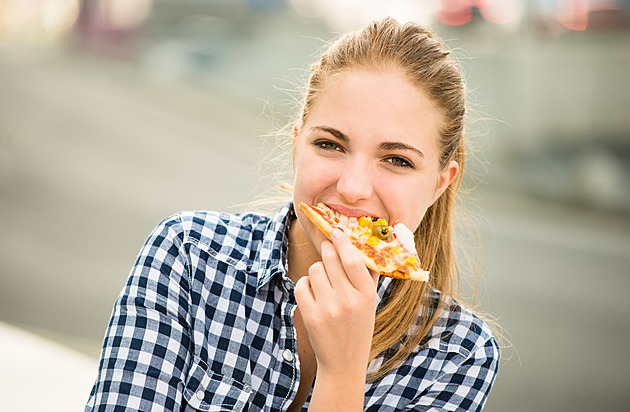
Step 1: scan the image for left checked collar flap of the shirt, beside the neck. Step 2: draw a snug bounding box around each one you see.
[256,201,296,289]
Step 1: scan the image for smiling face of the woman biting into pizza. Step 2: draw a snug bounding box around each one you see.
[294,70,458,250]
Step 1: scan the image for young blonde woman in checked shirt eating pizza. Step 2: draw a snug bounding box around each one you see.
[86,19,499,411]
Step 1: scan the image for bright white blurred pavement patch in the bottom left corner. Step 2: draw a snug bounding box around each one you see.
[0,322,98,412]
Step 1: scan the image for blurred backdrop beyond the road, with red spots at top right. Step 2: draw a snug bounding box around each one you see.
[0,0,630,213]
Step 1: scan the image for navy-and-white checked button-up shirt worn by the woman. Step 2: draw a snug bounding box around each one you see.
[85,203,499,412]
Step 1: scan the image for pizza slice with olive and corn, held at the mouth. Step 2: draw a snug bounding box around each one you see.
[298,202,429,282]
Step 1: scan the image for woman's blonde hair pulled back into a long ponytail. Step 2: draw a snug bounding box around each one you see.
[300,18,466,380]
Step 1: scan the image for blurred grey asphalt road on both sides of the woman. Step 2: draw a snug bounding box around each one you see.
[0,43,630,412]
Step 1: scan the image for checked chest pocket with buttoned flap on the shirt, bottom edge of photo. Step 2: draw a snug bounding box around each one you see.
[184,363,252,412]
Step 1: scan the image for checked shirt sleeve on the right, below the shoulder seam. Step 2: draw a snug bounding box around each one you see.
[405,338,499,411]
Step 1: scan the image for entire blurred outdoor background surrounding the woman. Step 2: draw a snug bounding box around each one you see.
[0,0,630,412]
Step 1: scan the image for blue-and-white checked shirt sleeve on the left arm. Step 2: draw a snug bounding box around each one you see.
[85,217,191,412]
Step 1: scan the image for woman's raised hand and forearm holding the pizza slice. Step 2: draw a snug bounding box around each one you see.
[295,229,378,410]
